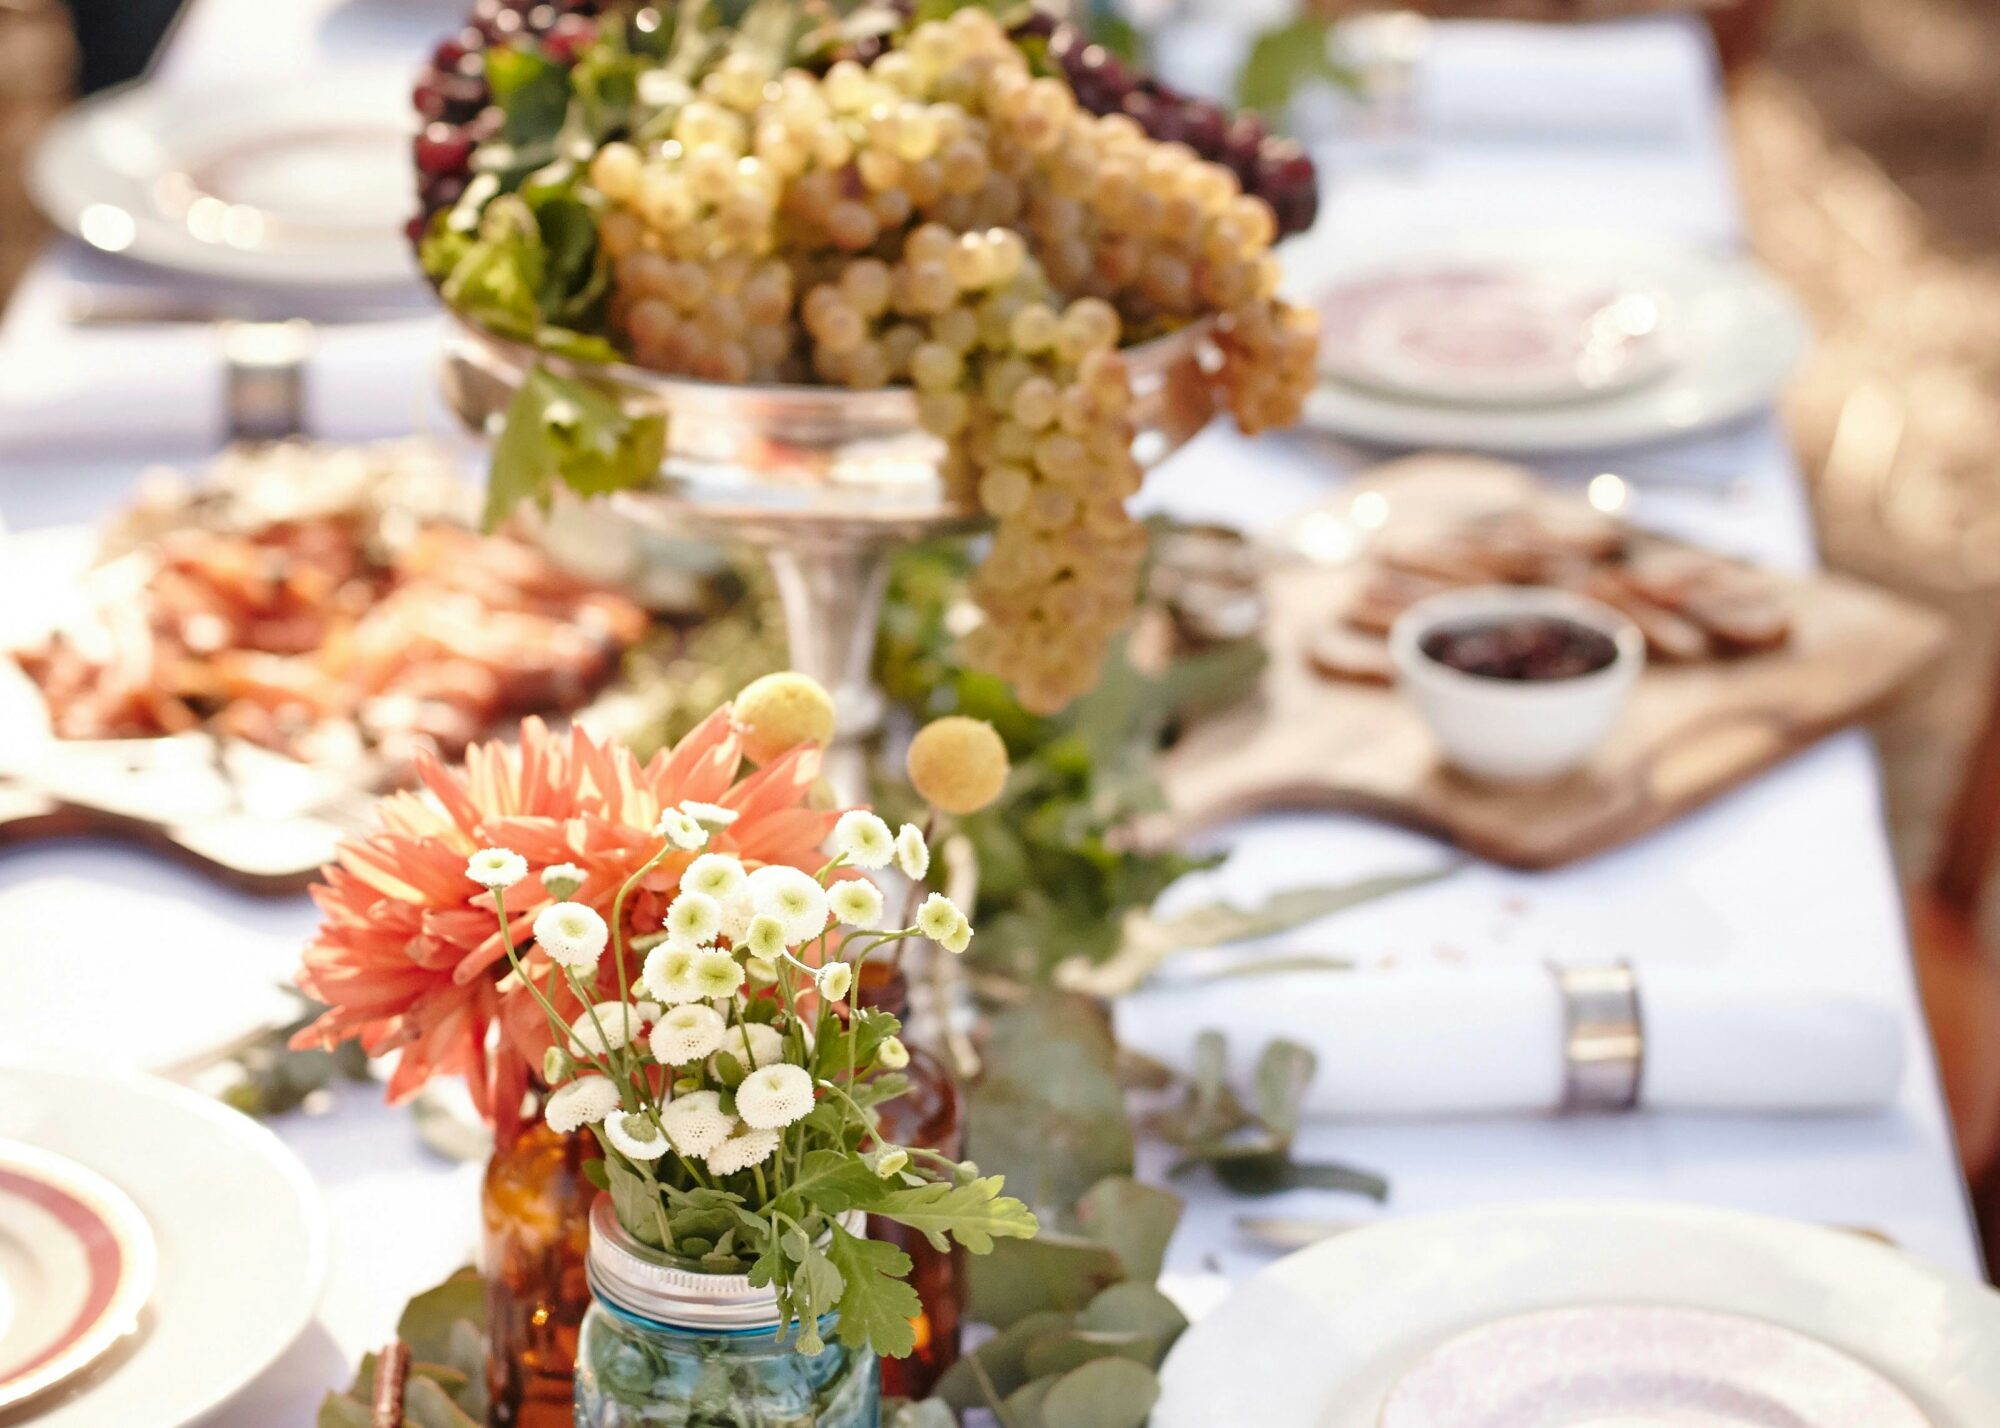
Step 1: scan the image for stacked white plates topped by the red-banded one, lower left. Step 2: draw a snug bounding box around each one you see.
[0,1066,326,1428]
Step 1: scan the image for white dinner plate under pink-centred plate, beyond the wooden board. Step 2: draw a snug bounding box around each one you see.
[1286,232,1810,452]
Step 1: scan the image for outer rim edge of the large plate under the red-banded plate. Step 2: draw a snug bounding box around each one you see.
[0,1060,332,1428]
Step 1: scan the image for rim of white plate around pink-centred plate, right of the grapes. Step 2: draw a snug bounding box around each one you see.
[1284,228,1812,456]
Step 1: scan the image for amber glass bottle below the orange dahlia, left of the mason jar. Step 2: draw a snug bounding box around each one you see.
[480,1112,596,1428]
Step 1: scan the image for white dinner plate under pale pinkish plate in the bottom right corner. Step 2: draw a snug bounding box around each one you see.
[1152,1200,2000,1428]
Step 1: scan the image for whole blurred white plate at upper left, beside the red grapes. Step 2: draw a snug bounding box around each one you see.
[28,66,416,288]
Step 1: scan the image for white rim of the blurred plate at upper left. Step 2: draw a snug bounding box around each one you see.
[22,64,418,290]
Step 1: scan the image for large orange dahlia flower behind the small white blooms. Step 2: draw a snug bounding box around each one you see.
[292,706,840,1136]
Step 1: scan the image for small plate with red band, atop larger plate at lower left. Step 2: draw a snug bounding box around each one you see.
[0,1140,156,1408]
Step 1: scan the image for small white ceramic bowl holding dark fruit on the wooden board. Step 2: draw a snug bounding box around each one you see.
[1388,586,1646,784]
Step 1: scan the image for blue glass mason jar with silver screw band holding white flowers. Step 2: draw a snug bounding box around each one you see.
[576,1196,882,1428]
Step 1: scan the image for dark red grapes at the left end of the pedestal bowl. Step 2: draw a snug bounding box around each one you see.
[410,0,600,242]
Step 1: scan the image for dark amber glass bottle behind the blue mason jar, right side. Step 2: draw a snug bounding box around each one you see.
[856,962,966,1398]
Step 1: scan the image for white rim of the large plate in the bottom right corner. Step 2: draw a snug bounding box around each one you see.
[1150,1198,2000,1428]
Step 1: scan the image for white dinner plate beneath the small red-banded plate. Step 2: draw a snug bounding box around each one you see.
[0,1064,326,1428]
